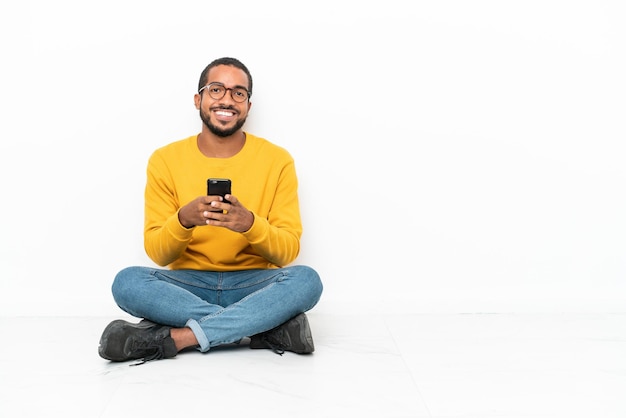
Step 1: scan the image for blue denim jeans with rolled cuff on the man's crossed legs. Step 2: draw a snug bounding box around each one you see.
[112,266,322,352]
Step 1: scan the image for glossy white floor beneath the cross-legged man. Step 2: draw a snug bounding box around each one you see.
[0,311,626,418]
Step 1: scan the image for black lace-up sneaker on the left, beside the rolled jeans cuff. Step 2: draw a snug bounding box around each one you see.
[98,319,178,364]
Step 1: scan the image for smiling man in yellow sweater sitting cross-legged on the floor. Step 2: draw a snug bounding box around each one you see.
[98,58,322,362]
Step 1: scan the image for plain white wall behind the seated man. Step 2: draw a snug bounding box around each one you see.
[0,0,626,315]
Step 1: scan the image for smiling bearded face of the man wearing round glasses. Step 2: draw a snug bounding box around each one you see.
[194,65,252,137]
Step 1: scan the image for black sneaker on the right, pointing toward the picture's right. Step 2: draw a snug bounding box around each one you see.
[250,313,315,356]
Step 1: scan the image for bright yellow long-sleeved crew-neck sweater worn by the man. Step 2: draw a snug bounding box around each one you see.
[144,133,302,271]
